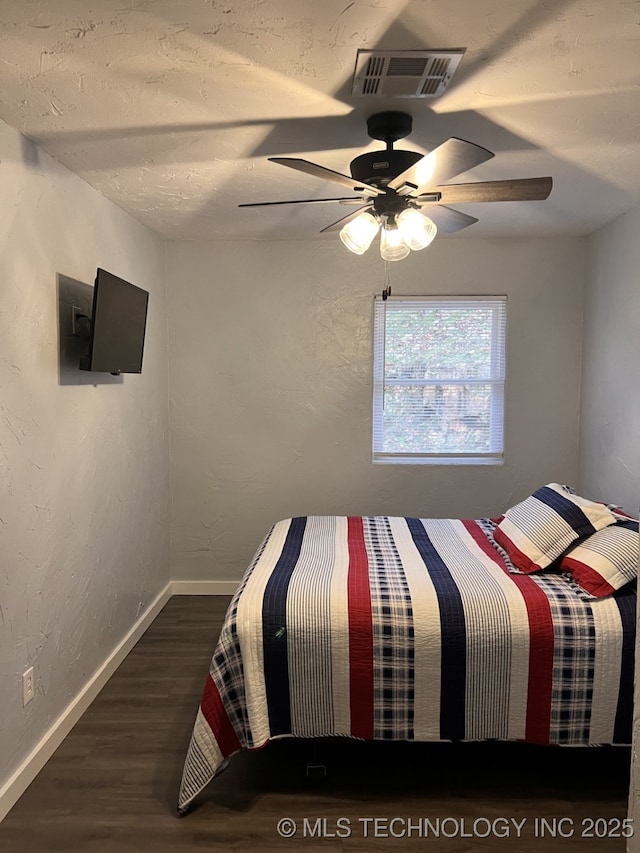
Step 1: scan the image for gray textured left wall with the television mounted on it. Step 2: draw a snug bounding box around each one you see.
[0,116,169,788]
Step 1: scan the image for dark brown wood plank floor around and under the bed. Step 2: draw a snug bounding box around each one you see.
[0,596,630,853]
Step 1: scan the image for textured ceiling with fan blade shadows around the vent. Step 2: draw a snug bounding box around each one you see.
[0,0,640,240]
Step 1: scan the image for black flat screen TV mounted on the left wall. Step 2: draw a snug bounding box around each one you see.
[80,268,149,375]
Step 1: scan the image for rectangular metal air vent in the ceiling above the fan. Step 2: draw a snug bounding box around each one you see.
[351,48,466,98]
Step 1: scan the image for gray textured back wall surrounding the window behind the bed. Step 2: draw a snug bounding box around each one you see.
[167,238,584,580]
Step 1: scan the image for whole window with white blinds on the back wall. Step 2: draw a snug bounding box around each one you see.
[373,296,506,465]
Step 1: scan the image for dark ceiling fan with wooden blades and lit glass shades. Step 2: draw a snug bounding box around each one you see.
[238,112,553,261]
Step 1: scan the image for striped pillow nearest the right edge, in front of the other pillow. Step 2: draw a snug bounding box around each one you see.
[560,520,640,598]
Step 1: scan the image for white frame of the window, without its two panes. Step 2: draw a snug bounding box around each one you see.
[372,294,507,466]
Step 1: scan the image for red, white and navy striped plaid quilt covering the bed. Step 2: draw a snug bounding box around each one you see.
[178,516,635,810]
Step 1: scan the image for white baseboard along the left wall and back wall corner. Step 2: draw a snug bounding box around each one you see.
[0,581,239,821]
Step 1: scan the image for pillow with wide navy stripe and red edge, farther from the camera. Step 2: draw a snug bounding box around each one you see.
[493,483,616,574]
